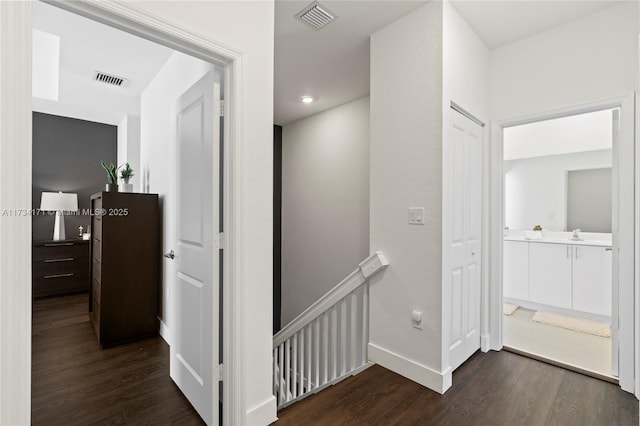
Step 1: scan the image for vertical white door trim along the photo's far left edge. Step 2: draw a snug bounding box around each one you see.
[0,2,32,425]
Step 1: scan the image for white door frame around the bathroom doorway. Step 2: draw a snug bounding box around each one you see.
[485,93,640,393]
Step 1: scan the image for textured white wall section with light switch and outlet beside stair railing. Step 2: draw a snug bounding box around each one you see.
[369,2,443,389]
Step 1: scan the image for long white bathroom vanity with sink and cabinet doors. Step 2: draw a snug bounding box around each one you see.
[503,233,612,318]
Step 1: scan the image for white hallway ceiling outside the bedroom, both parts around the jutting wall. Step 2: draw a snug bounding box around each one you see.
[274,0,619,125]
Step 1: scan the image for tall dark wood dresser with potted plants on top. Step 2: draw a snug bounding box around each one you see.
[89,192,161,346]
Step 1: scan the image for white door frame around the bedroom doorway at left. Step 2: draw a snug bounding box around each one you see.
[0,0,246,424]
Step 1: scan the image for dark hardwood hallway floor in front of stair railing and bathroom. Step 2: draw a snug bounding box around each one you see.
[274,351,638,426]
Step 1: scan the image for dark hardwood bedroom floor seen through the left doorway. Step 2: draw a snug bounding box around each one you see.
[31,294,203,425]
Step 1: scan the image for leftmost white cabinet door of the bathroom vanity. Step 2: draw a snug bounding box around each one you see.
[502,241,529,300]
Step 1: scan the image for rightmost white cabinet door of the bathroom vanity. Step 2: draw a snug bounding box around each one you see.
[573,245,612,316]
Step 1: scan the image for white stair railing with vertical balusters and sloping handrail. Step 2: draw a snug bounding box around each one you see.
[273,252,388,409]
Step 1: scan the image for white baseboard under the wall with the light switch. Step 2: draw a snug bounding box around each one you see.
[368,343,452,394]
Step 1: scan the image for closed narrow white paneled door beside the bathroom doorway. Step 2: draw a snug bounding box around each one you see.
[446,110,482,369]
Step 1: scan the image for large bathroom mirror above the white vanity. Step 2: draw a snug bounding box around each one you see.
[503,110,613,233]
